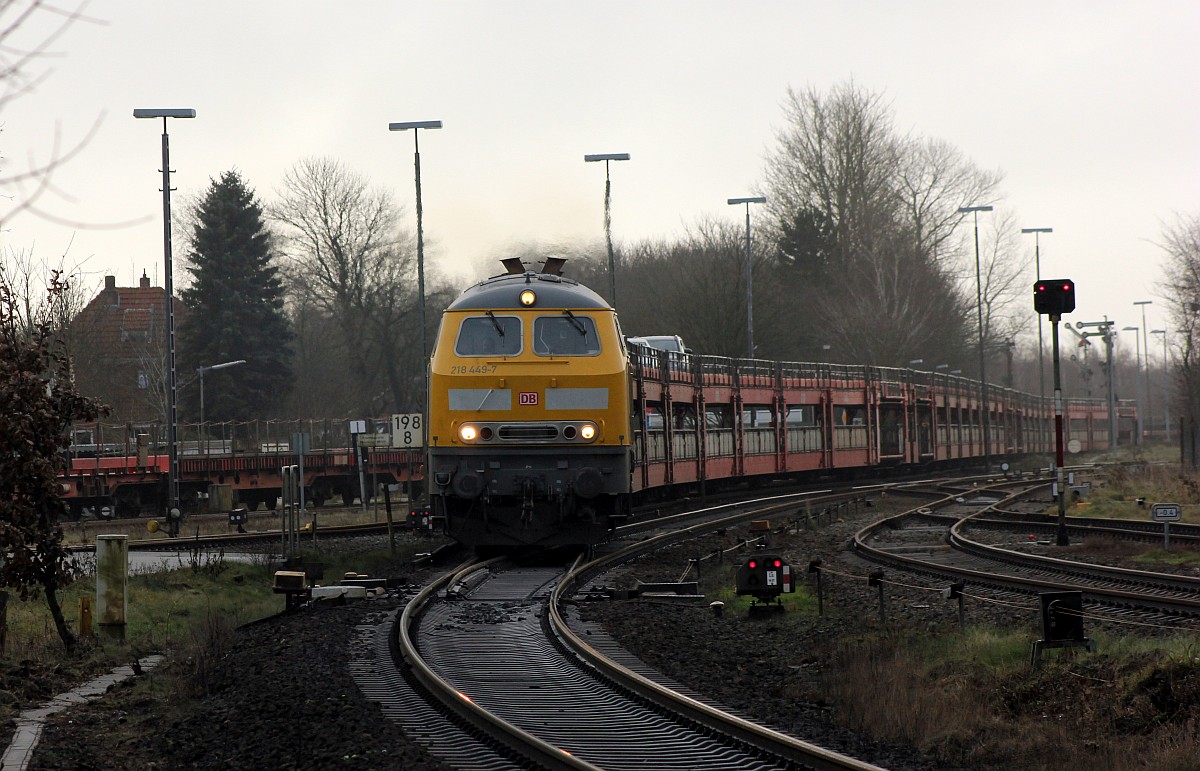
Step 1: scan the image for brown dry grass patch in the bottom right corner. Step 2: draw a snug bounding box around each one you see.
[828,630,1200,770]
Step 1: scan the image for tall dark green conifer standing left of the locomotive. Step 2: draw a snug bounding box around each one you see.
[179,171,293,422]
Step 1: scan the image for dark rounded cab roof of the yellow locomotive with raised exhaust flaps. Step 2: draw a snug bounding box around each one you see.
[446,257,610,311]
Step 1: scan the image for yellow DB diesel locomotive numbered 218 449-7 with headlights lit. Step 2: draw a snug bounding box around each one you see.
[426,258,632,548]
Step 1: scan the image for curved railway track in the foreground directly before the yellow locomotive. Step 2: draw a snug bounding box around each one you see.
[345,485,902,770]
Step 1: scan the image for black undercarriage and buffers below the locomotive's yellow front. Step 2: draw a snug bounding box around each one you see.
[431,447,629,546]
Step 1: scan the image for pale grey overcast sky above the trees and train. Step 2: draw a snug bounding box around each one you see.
[0,0,1200,353]
